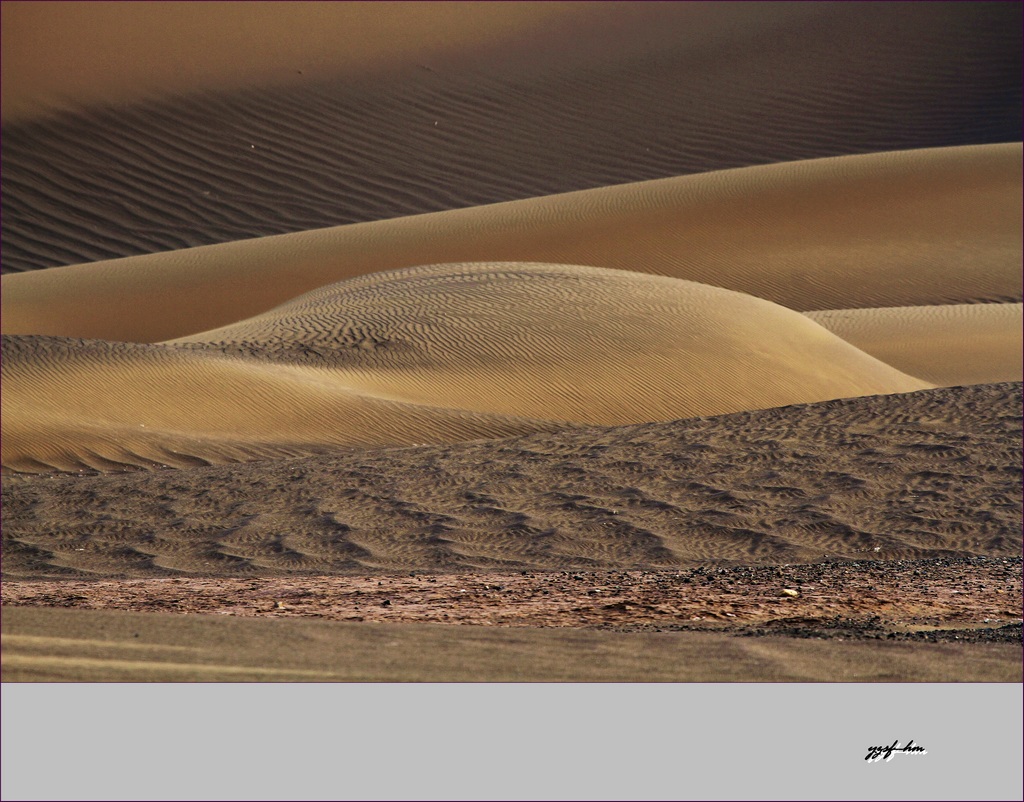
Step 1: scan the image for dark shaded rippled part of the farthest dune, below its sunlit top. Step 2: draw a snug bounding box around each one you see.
[0,3,1021,278]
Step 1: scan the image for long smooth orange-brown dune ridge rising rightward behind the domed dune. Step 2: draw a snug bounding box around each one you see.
[2,143,1022,342]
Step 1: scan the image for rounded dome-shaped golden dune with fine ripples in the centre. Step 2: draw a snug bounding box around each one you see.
[172,262,927,417]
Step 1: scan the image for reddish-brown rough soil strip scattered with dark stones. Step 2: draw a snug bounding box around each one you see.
[3,557,1022,641]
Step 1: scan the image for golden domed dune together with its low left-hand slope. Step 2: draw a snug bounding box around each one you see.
[3,263,930,470]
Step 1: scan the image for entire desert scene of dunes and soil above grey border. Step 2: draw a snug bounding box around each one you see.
[0,2,1024,682]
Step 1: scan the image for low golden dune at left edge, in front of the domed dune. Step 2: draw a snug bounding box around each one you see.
[2,337,560,472]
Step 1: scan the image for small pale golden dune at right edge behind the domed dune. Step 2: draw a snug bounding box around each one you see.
[805,303,1024,387]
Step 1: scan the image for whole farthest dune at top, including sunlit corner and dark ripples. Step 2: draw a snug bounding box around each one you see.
[0,2,1021,272]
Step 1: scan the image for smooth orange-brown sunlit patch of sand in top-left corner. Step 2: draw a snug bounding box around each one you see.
[3,2,589,122]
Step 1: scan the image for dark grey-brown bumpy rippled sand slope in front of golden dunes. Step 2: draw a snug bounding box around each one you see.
[2,383,1022,578]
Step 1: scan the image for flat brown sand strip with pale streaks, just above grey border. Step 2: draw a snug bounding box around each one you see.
[3,607,1021,682]
